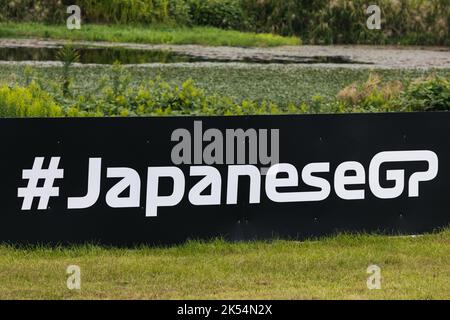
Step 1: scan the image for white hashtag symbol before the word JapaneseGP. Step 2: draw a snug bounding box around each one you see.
[17,157,64,210]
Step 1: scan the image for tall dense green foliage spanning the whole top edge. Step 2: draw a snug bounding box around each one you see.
[0,0,450,45]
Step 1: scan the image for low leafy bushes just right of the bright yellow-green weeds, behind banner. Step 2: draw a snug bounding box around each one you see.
[69,76,288,116]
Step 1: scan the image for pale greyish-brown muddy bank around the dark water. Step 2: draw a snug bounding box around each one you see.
[0,39,450,69]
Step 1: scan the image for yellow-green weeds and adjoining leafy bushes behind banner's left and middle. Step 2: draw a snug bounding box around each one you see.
[0,69,299,117]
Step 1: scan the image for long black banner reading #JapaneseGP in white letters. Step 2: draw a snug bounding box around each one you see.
[0,113,450,245]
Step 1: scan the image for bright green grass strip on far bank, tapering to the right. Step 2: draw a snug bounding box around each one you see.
[0,23,301,47]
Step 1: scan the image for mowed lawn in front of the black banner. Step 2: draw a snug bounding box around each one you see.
[0,229,450,299]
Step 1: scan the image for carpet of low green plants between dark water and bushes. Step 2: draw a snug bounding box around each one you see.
[0,65,450,105]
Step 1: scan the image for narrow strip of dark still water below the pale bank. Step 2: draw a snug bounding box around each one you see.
[0,47,370,64]
